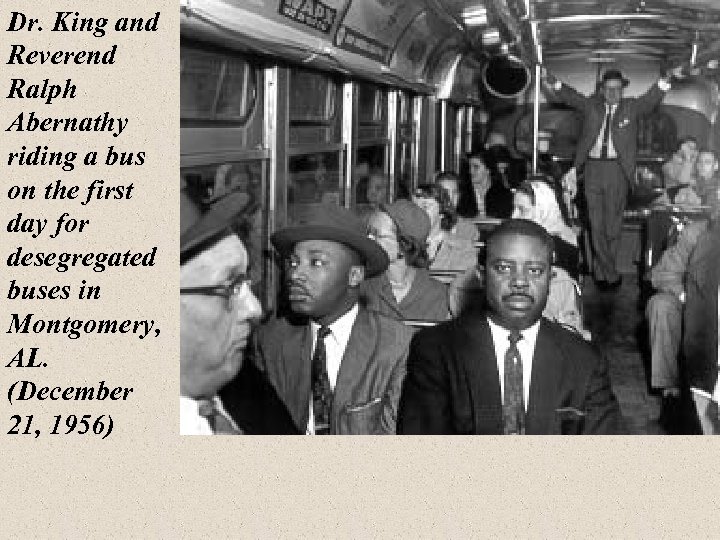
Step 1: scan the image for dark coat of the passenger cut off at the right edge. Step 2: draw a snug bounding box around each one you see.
[683,224,720,394]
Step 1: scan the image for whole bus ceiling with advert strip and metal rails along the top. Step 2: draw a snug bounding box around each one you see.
[180,0,720,96]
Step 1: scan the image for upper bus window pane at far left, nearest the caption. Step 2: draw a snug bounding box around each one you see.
[180,48,256,124]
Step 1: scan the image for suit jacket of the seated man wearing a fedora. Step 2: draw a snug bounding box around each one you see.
[222,307,412,434]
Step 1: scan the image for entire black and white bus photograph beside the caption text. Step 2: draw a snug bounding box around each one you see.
[180,0,720,435]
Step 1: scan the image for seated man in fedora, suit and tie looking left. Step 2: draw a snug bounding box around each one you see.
[223,205,412,435]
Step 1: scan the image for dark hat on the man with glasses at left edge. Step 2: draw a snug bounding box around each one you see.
[180,190,250,254]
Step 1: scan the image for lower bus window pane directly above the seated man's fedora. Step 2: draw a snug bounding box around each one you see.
[287,151,343,223]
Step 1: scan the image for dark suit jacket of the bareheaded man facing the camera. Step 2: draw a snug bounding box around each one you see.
[398,313,624,435]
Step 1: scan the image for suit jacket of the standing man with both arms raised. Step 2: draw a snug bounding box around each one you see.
[555,83,665,181]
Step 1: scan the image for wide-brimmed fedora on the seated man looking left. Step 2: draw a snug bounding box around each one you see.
[270,204,388,277]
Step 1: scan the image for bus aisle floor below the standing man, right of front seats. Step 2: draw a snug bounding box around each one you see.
[583,274,694,435]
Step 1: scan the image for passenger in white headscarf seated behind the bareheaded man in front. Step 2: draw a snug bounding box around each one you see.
[513,179,590,339]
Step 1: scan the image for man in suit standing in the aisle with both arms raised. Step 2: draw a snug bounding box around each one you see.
[543,65,680,290]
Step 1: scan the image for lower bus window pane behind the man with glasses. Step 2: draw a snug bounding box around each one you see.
[180,160,269,305]
